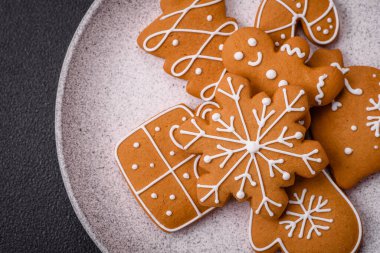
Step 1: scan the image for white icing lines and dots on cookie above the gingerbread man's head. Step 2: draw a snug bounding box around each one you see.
[255,0,339,45]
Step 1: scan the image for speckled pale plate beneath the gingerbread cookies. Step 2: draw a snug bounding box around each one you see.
[56,0,380,252]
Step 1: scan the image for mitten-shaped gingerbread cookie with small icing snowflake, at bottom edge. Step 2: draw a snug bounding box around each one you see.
[250,171,362,253]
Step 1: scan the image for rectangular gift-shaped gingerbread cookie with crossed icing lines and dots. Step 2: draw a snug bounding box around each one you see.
[116,105,212,232]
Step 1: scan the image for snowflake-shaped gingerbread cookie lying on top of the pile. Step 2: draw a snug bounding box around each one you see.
[171,74,328,216]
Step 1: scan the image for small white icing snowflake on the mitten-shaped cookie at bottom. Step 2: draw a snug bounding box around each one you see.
[279,188,334,240]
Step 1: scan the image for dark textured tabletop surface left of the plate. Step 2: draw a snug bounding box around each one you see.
[0,0,98,252]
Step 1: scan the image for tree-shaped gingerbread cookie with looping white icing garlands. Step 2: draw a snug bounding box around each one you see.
[137,0,238,101]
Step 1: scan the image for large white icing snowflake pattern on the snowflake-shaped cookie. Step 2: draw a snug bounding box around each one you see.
[170,77,322,216]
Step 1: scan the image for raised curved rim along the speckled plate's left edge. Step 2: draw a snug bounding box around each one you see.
[54,0,108,253]
